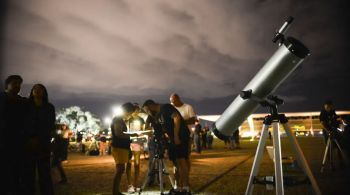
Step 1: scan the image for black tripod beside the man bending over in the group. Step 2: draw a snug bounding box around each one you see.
[139,138,174,194]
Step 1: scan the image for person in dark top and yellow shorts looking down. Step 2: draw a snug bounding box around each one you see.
[111,102,137,195]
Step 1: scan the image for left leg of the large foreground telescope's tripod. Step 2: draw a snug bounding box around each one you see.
[245,124,270,195]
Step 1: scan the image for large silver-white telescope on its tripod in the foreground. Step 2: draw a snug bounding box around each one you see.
[211,17,321,195]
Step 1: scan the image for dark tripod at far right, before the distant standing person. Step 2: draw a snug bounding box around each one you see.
[321,129,347,173]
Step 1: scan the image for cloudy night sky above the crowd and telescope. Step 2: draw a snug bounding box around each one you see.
[0,0,350,117]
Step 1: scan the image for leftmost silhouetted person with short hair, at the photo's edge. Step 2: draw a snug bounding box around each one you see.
[0,75,28,194]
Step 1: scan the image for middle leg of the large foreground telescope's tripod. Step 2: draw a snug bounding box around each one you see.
[272,122,284,195]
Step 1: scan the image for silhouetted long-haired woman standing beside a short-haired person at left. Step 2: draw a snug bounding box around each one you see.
[24,84,56,195]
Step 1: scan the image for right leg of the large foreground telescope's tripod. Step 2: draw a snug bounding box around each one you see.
[283,123,321,195]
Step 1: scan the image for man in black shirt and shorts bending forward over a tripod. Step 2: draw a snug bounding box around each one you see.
[143,100,191,194]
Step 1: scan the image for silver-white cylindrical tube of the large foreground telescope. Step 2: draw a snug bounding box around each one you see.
[211,37,310,139]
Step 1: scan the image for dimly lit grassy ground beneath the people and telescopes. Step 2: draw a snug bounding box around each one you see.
[54,137,350,195]
